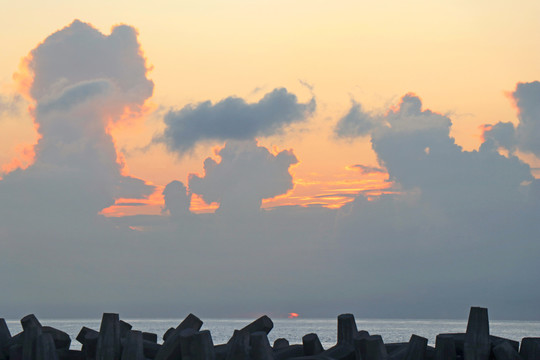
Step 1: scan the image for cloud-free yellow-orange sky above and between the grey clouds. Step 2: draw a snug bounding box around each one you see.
[0,0,540,215]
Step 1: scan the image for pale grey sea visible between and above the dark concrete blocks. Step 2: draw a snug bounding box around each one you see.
[6,318,540,349]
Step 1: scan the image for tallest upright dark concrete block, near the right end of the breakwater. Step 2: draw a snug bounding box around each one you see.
[464,307,491,360]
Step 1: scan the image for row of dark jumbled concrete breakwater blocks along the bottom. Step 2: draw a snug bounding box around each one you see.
[0,308,540,360]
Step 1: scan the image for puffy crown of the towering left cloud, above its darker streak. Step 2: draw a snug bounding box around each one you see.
[27,20,154,111]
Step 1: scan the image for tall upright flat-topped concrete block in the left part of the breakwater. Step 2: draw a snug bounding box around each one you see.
[96,313,121,360]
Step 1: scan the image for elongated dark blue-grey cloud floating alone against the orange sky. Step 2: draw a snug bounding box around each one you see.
[154,88,316,154]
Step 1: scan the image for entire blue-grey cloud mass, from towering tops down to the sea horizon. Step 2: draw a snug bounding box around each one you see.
[0,22,540,320]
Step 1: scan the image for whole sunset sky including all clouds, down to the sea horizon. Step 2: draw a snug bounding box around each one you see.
[0,0,540,320]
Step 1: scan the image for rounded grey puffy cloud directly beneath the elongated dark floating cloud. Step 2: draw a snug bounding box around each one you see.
[189,140,298,214]
